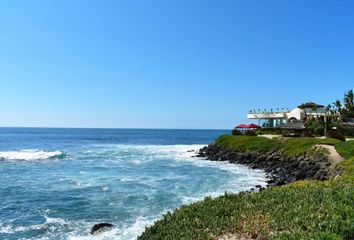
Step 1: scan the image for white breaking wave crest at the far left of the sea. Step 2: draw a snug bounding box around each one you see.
[0,149,63,160]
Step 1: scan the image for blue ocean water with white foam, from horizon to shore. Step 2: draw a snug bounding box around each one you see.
[0,128,266,240]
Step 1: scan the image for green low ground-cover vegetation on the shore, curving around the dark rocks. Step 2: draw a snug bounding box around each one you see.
[138,136,354,240]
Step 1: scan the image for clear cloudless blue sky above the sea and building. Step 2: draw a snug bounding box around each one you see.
[0,0,354,129]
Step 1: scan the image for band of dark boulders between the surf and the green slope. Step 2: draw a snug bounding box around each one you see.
[196,144,339,188]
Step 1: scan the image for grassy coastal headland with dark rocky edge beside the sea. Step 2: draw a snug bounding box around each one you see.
[138,135,354,240]
